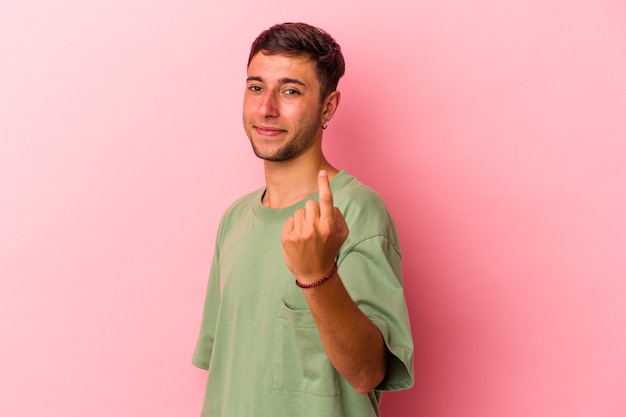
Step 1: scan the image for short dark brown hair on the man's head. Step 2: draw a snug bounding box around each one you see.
[248,23,345,102]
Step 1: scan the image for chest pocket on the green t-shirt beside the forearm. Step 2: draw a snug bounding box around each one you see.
[273,302,340,397]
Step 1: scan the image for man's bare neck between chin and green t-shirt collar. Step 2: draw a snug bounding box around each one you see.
[263,155,338,208]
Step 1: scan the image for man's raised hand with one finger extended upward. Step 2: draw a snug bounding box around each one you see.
[281,170,349,284]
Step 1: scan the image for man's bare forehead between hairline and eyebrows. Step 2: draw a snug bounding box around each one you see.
[248,52,319,86]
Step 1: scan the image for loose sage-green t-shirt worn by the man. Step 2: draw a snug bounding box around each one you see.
[193,171,413,417]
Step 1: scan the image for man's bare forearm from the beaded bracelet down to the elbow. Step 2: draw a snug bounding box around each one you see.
[303,275,387,394]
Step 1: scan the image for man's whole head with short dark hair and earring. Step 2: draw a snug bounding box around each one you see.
[243,23,344,162]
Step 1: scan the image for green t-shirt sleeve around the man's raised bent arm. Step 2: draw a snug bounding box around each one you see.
[338,236,413,391]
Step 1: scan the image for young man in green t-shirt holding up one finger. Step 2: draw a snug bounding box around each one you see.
[193,23,413,417]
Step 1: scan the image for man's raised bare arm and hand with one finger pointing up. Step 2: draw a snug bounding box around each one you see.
[282,171,387,393]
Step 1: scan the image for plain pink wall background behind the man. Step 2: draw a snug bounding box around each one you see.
[0,0,626,417]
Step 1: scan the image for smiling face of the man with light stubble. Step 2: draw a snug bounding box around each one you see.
[243,52,322,161]
